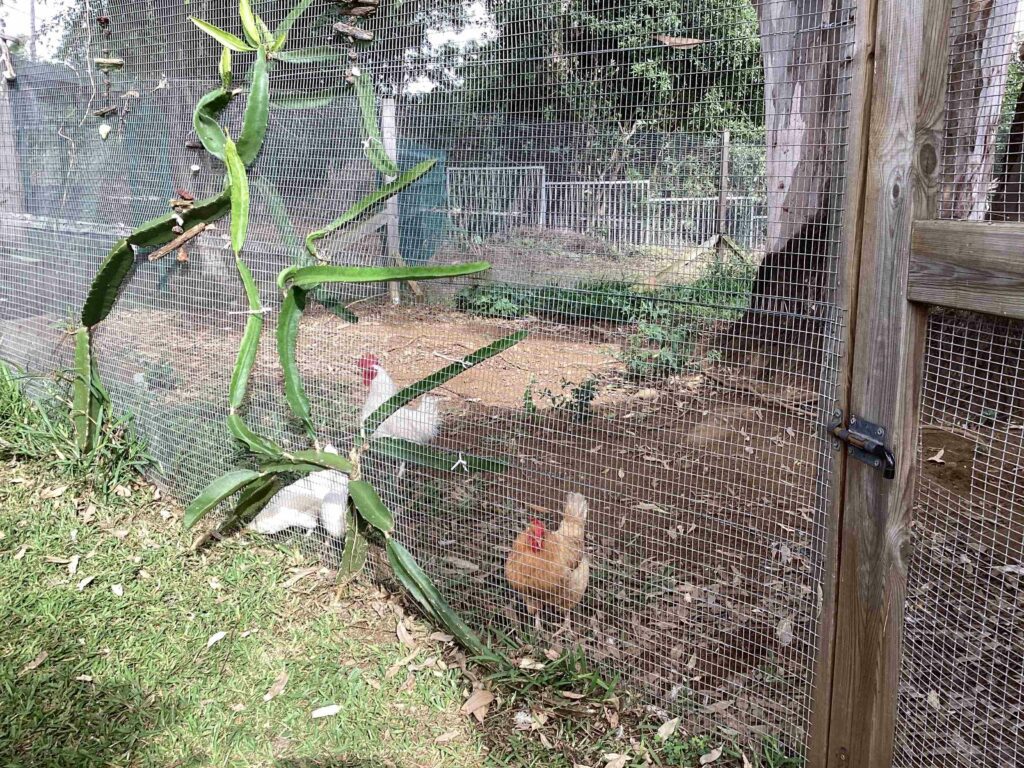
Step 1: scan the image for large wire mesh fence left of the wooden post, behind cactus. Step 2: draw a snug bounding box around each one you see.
[0,0,854,755]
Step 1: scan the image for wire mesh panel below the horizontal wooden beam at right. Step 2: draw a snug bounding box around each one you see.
[895,309,1024,767]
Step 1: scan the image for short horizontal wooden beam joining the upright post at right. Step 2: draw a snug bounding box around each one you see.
[907,221,1024,319]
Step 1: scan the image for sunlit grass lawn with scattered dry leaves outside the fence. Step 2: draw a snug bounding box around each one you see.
[0,463,484,768]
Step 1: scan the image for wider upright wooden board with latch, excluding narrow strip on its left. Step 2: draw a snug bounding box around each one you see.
[827,0,951,768]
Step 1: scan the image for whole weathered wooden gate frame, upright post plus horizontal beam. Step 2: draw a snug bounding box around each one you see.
[808,0,1024,768]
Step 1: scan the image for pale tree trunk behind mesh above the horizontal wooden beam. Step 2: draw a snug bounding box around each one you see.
[939,0,1017,220]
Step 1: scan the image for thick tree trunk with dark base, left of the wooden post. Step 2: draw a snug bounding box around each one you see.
[727,0,853,372]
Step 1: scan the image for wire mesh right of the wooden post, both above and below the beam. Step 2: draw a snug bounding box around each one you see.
[895,0,1024,768]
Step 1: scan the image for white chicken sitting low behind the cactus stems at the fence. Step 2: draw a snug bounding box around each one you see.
[248,445,348,539]
